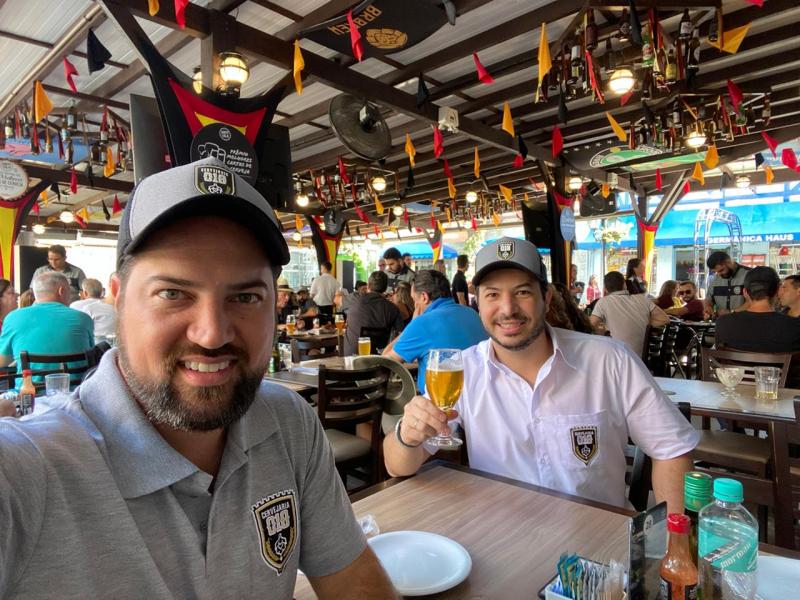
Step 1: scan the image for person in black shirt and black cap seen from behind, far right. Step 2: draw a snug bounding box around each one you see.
[716,267,800,352]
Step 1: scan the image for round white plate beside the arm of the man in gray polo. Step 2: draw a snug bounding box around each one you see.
[369,531,472,596]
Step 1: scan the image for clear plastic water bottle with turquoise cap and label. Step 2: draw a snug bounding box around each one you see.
[698,478,758,600]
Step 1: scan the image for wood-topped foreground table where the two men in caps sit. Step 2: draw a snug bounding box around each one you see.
[295,461,800,600]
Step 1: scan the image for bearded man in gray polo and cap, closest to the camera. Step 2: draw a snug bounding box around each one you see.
[0,159,395,599]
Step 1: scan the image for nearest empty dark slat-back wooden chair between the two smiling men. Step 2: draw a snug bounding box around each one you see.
[317,365,389,491]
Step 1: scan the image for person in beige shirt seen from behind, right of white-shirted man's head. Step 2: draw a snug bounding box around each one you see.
[589,271,669,356]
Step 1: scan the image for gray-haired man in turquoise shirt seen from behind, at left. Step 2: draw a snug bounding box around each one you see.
[0,271,94,368]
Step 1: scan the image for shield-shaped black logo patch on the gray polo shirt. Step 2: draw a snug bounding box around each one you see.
[252,490,297,575]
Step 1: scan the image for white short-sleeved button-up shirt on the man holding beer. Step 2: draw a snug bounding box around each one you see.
[454,327,699,506]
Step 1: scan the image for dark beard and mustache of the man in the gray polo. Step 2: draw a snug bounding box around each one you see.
[117,336,266,431]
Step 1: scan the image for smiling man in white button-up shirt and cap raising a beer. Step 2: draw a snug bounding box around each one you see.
[384,238,698,512]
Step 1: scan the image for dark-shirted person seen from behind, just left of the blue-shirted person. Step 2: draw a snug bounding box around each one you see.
[344,271,403,356]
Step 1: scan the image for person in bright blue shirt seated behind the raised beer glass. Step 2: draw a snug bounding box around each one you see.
[383,270,489,393]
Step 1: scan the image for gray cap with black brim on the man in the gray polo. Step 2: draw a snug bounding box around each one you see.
[117,158,289,275]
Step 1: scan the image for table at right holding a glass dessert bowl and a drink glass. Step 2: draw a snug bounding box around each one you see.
[656,377,800,548]
